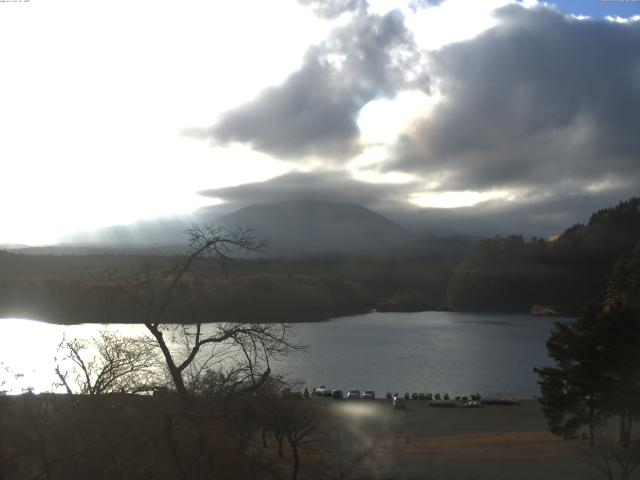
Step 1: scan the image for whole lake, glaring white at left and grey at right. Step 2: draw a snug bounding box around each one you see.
[0,312,554,397]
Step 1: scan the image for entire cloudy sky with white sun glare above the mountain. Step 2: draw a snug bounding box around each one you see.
[0,0,640,245]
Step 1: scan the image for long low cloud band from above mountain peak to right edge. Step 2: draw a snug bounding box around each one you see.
[200,171,637,237]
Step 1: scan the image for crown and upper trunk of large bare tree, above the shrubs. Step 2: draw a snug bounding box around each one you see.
[100,225,296,397]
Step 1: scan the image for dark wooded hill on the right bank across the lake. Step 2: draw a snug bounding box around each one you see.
[447,198,640,313]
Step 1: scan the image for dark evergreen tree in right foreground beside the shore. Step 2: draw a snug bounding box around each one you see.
[535,243,640,445]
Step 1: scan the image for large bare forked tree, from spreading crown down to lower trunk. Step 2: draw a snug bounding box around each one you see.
[94,225,298,479]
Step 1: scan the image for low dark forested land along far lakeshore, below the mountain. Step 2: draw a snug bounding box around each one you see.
[0,251,458,323]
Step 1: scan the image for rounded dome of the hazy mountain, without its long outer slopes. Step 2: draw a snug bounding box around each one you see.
[214,201,414,256]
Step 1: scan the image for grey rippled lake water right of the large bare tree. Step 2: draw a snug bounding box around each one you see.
[278,312,554,397]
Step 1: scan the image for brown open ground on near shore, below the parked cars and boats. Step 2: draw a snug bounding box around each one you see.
[326,400,600,480]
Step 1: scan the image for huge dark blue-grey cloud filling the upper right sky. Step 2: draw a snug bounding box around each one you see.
[389,6,640,194]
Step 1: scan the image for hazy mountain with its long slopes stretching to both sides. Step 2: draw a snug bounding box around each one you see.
[22,201,479,261]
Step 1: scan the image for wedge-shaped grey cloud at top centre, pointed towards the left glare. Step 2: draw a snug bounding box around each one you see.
[191,2,424,160]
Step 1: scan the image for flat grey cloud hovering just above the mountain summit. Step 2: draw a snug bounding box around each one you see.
[200,172,416,210]
